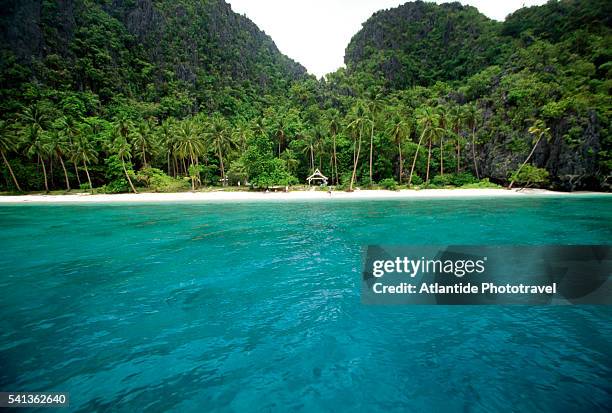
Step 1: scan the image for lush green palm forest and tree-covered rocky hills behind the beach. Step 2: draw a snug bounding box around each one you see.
[0,0,612,193]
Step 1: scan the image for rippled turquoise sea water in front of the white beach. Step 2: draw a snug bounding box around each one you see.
[0,197,612,412]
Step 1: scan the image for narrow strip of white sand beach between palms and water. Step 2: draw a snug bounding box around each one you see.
[0,189,612,204]
